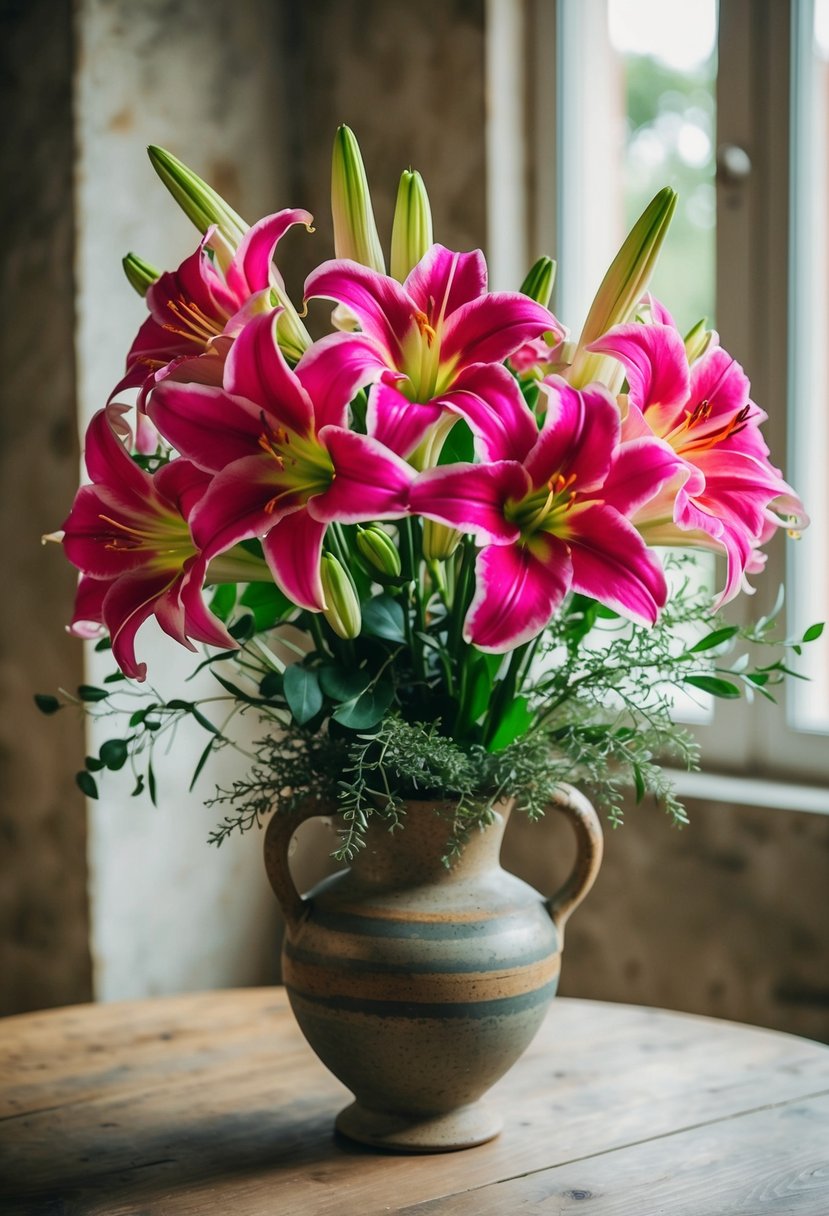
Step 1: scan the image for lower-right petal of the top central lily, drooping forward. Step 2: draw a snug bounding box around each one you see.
[439,364,538,461]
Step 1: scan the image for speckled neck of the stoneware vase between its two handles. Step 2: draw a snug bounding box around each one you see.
[351,801,512,885]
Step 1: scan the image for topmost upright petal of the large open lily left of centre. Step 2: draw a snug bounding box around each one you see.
[224,309,314,437]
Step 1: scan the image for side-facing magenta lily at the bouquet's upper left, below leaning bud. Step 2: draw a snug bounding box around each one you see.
[109,210,312,452]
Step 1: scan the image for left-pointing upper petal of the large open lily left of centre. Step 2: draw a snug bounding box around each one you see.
[147,379,263,473]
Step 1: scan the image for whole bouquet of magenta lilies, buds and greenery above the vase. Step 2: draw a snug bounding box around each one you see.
[36,128,820,861]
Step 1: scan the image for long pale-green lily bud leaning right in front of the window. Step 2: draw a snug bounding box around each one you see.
[566,186,677,392]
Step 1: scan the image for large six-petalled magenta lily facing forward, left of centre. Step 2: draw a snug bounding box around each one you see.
[148,309,415,612]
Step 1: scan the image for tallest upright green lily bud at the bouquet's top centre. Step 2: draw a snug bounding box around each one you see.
[331,126,385,275]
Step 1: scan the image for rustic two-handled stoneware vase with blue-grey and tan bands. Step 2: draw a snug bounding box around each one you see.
[265,789,602,1153]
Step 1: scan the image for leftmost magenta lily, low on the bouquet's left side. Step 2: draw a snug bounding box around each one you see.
[63,406,236,680]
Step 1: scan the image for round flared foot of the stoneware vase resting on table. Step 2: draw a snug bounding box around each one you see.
[335,1102,503,1153]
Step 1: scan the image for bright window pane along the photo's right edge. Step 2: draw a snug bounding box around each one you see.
[788,0,829,731]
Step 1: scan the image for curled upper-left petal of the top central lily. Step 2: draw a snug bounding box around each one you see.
[305,258,418,367]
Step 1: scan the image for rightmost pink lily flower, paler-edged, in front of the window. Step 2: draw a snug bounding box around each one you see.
[588,302,808,606]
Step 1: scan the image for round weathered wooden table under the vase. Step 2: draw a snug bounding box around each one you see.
[0,989,829,1216]
